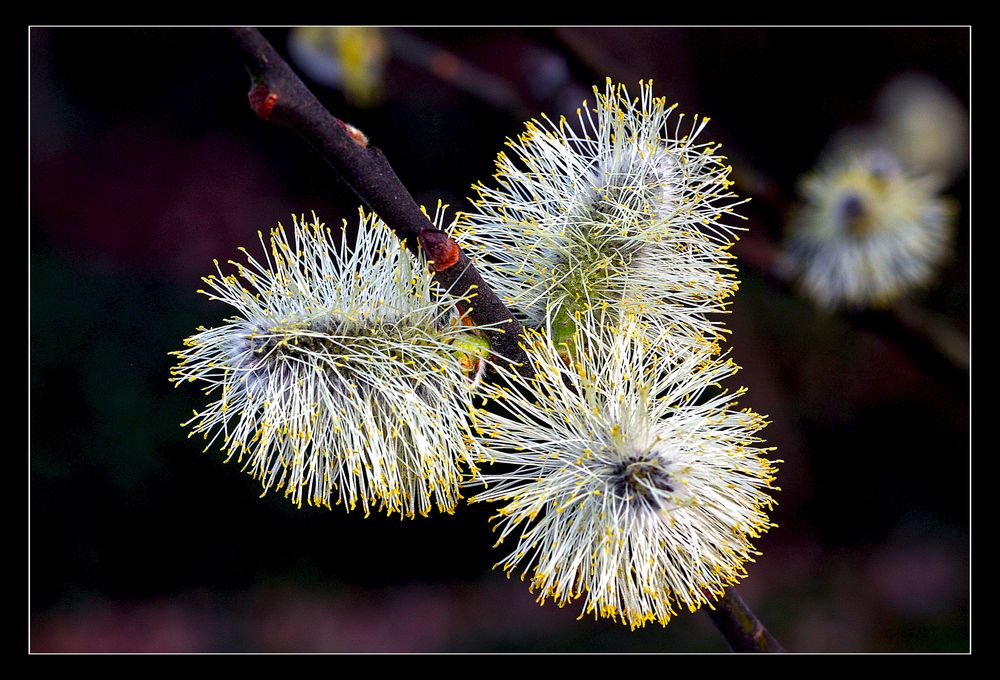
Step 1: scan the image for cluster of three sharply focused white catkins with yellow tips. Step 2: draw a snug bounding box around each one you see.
[172,81,774,627]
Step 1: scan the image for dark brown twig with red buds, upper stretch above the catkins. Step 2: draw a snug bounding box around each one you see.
[225,28,526,366]
